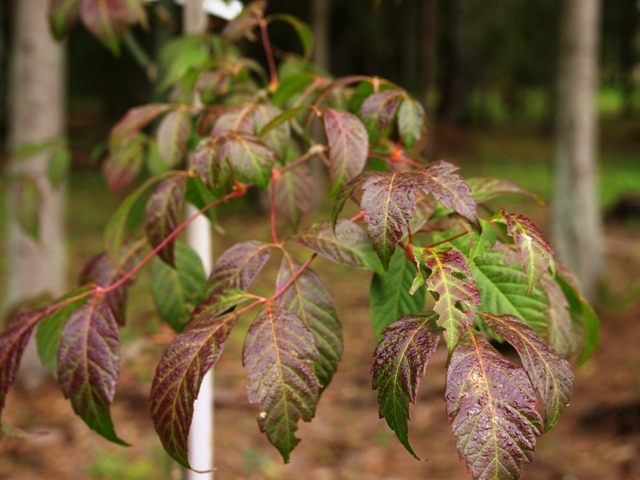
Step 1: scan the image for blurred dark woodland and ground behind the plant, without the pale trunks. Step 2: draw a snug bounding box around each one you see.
[0,0,640,480]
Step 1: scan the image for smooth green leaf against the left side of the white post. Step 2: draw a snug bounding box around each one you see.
[151,242,207,332]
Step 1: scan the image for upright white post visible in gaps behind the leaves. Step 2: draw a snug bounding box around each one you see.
[183,0,214,480]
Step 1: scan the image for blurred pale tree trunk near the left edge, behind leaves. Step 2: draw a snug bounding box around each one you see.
[7,0,66,387]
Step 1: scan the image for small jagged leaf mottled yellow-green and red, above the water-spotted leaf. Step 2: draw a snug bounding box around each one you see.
[421,248,480,352]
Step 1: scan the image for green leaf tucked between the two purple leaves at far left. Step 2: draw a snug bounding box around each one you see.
[36,288,90,377]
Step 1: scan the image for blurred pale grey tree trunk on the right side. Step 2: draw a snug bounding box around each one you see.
[553,0,604,300]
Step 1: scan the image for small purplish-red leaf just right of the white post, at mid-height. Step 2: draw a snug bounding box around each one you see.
[209,240,271,292]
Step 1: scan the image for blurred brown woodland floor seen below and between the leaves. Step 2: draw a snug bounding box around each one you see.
[0,122,640,480]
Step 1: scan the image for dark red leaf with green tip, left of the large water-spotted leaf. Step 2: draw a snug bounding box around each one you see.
[371,312,440,459]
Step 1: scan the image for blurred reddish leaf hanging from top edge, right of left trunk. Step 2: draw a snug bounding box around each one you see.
[80,0,130,53]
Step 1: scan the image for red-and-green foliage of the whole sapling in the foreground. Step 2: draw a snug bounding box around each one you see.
[0,0,598,479]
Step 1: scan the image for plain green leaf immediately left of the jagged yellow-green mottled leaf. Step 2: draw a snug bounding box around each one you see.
[369,250,426,341]
